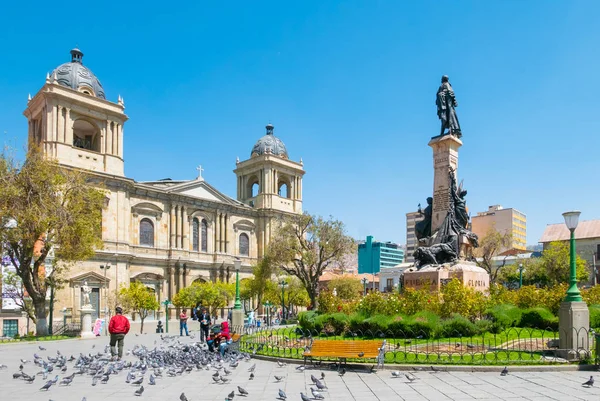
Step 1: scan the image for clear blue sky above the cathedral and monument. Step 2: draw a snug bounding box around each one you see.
[0,0,600,243]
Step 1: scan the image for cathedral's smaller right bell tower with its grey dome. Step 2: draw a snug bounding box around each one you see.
[234,124,304,214]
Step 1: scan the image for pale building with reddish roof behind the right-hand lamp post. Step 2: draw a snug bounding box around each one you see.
[540,220,600,285]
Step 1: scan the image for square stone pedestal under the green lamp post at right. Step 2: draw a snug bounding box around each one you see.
[558,301,590,361]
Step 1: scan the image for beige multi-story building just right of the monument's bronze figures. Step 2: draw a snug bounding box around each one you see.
[471,205,527,250]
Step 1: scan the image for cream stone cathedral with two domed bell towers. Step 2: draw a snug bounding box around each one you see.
[24,49,304,321]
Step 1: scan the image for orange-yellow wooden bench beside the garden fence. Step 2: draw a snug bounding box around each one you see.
[302,340,384,368]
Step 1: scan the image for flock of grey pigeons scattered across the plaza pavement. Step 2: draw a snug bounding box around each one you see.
[0,336,594,401]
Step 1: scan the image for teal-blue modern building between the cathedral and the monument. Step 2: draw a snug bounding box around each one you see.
[358,235,404,274]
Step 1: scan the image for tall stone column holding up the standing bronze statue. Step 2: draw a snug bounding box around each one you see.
[428,135,462,233]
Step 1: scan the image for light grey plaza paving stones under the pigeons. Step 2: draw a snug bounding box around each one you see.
[0,333,600,401]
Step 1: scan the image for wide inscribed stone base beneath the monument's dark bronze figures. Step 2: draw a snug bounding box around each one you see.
[403,260,490,292]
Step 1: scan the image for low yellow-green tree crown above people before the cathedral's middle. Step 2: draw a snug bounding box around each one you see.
[173,281,235,313]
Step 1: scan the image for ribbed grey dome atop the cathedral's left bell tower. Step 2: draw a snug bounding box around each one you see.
[50,48,106,99]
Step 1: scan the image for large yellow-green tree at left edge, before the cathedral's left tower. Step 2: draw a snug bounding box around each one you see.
[0,147,104,335]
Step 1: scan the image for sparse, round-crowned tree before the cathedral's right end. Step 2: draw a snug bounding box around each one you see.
[268,214,355,309]
